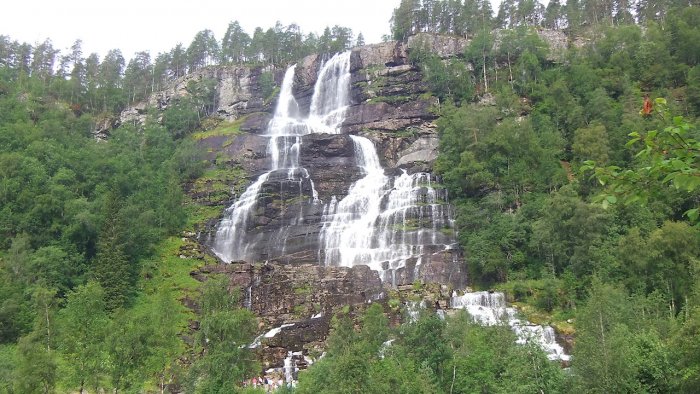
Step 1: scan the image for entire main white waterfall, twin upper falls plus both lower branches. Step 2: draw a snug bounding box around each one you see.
[213,52,454,283]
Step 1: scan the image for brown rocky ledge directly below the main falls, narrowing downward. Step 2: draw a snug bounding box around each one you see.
[193,263,387,368]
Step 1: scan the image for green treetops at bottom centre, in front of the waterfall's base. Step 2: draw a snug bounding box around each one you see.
[296,304,564,393]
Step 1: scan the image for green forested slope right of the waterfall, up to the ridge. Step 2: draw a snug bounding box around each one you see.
[393,0,700,393]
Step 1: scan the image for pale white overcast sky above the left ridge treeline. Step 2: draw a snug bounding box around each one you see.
[0,0,400,59]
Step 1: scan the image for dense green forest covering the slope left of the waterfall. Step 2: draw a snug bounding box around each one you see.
[0,25,216,393]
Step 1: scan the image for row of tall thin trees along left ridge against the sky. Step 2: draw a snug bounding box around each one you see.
[0,21,364,112]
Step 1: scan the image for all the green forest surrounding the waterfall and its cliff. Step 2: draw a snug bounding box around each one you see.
[0,0,700,393]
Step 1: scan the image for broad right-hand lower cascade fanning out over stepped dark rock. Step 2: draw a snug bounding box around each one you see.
[319,136,451,283]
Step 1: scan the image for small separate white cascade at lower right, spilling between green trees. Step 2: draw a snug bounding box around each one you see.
[450,291,571,361]
